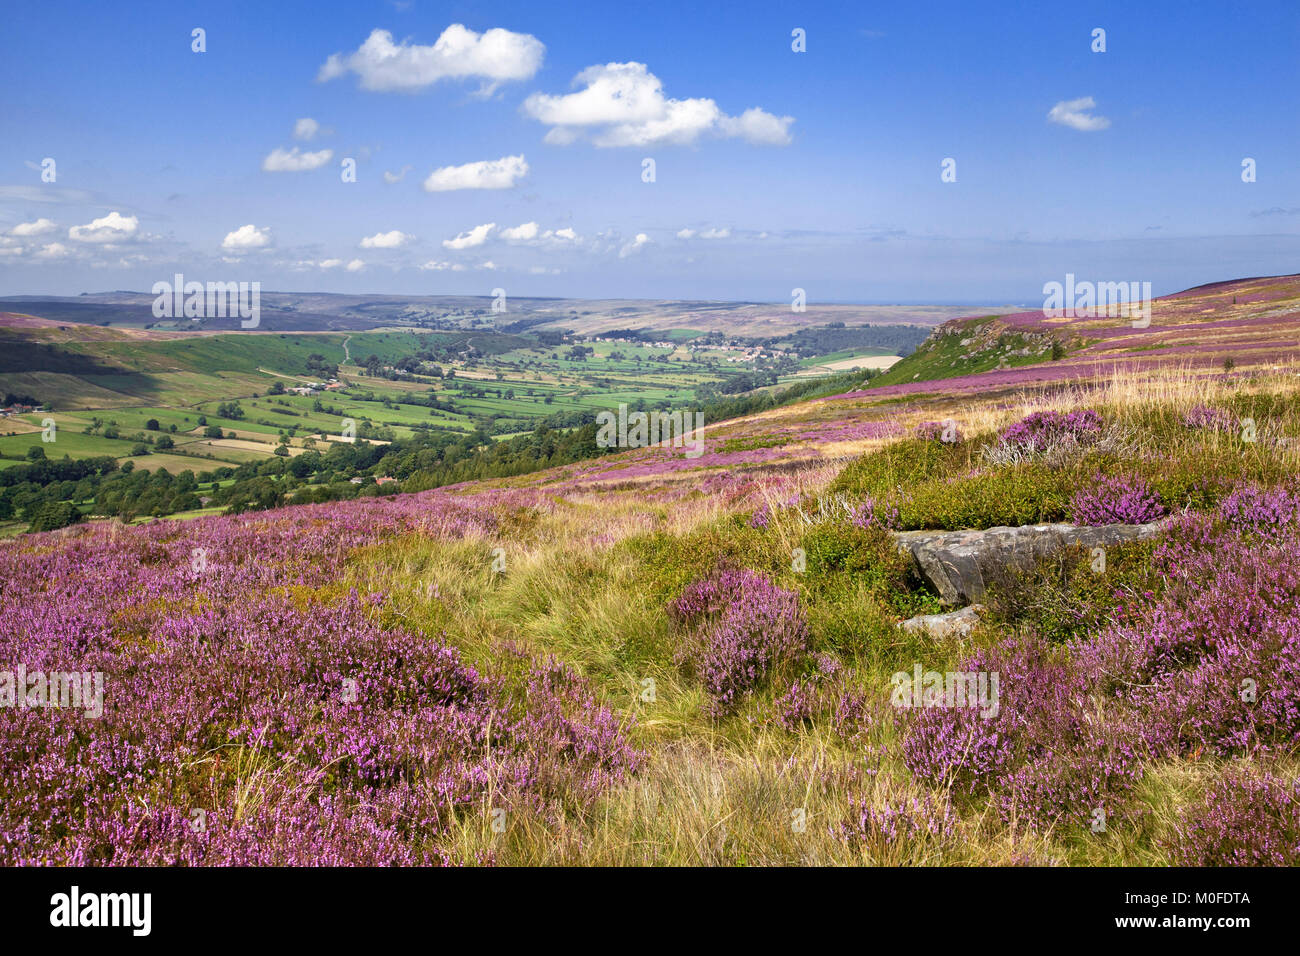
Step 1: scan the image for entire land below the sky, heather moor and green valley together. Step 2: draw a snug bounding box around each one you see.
[0,276,1300,866]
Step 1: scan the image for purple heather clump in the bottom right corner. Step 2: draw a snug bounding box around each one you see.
[1166,769,1300,866]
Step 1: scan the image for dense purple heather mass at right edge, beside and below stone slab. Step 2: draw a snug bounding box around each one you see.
[1073,509,1300,756]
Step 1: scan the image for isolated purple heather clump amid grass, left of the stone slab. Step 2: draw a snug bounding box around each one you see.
[668,570,809,715]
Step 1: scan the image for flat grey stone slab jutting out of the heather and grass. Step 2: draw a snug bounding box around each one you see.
[894,522,1165,607]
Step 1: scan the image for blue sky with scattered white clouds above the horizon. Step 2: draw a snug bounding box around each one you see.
[0,0,1300,303]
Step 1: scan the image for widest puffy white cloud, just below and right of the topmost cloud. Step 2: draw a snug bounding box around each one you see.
[523,62,794,146]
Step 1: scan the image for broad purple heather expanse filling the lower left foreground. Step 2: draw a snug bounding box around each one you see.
[0,493,637,865]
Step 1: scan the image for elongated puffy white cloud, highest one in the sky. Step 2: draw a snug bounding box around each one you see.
[316,23,546,92]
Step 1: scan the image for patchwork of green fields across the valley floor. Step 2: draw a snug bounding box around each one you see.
[0,326,879,471]
